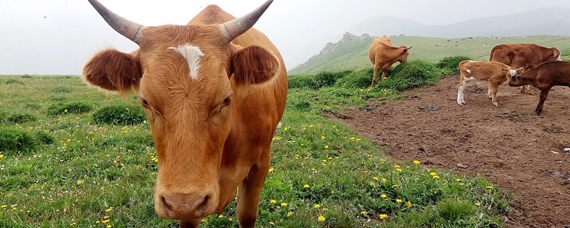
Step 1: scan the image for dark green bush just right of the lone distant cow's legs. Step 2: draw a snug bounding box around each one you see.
[378,60,441,91]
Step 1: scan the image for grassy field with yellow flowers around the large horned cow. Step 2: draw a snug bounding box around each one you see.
[0,75,513,227]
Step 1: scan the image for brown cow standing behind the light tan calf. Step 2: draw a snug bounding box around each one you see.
[489,44,562,94]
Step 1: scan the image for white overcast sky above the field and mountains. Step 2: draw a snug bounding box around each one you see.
[0,0,570,75]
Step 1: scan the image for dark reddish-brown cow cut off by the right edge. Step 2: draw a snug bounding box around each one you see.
[509,61,570,115]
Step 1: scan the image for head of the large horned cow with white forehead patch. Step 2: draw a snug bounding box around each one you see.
[83,0,280,220]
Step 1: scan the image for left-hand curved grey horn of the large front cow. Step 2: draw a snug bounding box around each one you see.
[89,0,144,44]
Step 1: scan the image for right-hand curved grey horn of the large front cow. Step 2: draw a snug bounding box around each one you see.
[220,0,273,41]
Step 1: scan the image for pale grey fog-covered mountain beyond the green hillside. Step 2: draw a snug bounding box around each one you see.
[347,8,570,38]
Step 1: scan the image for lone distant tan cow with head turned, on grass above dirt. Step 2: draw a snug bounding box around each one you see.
[368,35,412,88]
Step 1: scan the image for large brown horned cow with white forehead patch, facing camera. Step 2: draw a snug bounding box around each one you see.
[83,0,287,227]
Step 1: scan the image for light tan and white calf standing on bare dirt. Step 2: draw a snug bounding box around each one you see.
[457,60,516,106]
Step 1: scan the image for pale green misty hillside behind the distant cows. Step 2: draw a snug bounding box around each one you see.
[289,36,570,75]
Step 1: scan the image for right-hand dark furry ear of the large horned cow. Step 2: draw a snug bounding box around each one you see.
[231,46,279,84]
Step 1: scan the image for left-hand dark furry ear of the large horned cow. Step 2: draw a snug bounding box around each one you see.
[83,49,142,94]
